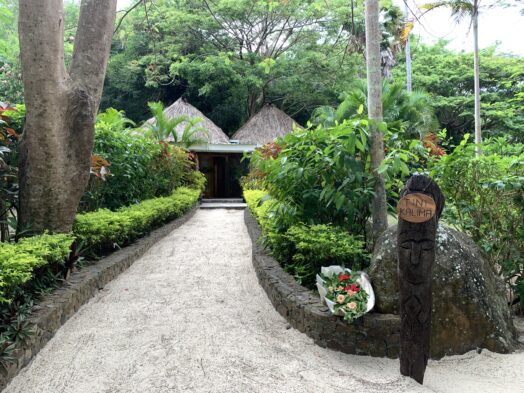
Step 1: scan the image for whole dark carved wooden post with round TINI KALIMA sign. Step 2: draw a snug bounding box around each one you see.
[397,175,444,384]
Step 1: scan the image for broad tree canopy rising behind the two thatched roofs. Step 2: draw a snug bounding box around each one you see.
[103,0,402,132]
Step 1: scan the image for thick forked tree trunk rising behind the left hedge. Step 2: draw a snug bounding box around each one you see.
[19,0,116,233]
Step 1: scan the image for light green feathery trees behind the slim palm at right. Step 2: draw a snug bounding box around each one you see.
[394,41,524,143]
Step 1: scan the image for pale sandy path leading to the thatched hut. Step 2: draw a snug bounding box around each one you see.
[5,210,524,393]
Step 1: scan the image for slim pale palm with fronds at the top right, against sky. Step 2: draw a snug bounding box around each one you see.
[421,0,482,156]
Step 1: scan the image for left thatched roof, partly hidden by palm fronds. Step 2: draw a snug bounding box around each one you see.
[146,97,229,144]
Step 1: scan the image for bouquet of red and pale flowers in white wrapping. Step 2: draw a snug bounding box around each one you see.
[317,266,375,322]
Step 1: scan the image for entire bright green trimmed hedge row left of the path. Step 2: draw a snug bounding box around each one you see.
[0,184,201,304]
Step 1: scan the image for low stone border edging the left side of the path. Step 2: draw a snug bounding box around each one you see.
[0,203,199,391]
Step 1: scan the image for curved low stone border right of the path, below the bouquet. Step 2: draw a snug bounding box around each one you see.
[244,209,400,358]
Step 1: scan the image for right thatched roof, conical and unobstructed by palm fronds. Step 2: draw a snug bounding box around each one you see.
[231,104,300,145]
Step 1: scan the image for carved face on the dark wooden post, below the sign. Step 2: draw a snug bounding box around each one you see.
[398,224,436,284]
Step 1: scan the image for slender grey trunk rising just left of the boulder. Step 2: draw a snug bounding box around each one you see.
[366,0,388,239]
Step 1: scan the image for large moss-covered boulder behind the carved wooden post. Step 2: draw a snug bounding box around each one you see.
[370,225,516,358]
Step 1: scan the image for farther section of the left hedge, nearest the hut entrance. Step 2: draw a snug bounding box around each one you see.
[73,187,201,254]
